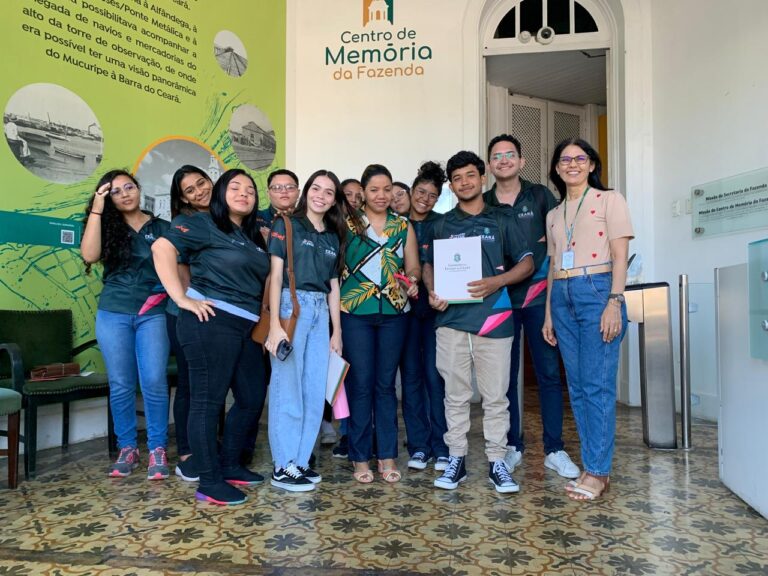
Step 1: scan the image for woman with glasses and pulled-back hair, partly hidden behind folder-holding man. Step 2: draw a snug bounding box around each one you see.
[400,162,448,470]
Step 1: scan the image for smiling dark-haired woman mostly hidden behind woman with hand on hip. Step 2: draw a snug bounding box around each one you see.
[166,164,213,482]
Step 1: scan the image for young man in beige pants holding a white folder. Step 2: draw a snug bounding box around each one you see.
[423,151,533,493]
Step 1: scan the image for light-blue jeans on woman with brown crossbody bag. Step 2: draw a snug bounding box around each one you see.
[269,290,331,468]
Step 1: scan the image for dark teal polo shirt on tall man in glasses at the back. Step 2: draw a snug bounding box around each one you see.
[483,178,557,308]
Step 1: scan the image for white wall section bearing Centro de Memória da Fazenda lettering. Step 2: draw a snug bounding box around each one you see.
[287,0,468,183]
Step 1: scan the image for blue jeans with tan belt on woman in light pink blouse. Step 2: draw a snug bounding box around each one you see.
[551,273,627,476]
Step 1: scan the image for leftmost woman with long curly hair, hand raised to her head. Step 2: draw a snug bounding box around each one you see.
[80,170,169,480]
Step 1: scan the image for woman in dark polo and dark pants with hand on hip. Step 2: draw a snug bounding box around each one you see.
[152,169,269,505]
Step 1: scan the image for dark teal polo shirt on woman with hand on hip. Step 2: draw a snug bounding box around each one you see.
[166,212,269,316]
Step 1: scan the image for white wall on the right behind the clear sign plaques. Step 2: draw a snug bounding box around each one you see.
[652,0,768,420]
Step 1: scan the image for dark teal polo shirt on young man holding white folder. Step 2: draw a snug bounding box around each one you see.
[427,206,531,338]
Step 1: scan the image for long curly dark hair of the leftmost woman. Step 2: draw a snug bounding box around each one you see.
[83,169,141,274]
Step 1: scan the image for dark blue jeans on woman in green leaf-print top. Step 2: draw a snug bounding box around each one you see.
[341,313,408,462]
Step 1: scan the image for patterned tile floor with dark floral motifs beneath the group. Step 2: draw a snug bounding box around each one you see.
[0,394,768,576]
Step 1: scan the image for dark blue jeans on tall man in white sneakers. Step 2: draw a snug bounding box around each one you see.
[507,304,563,454]
